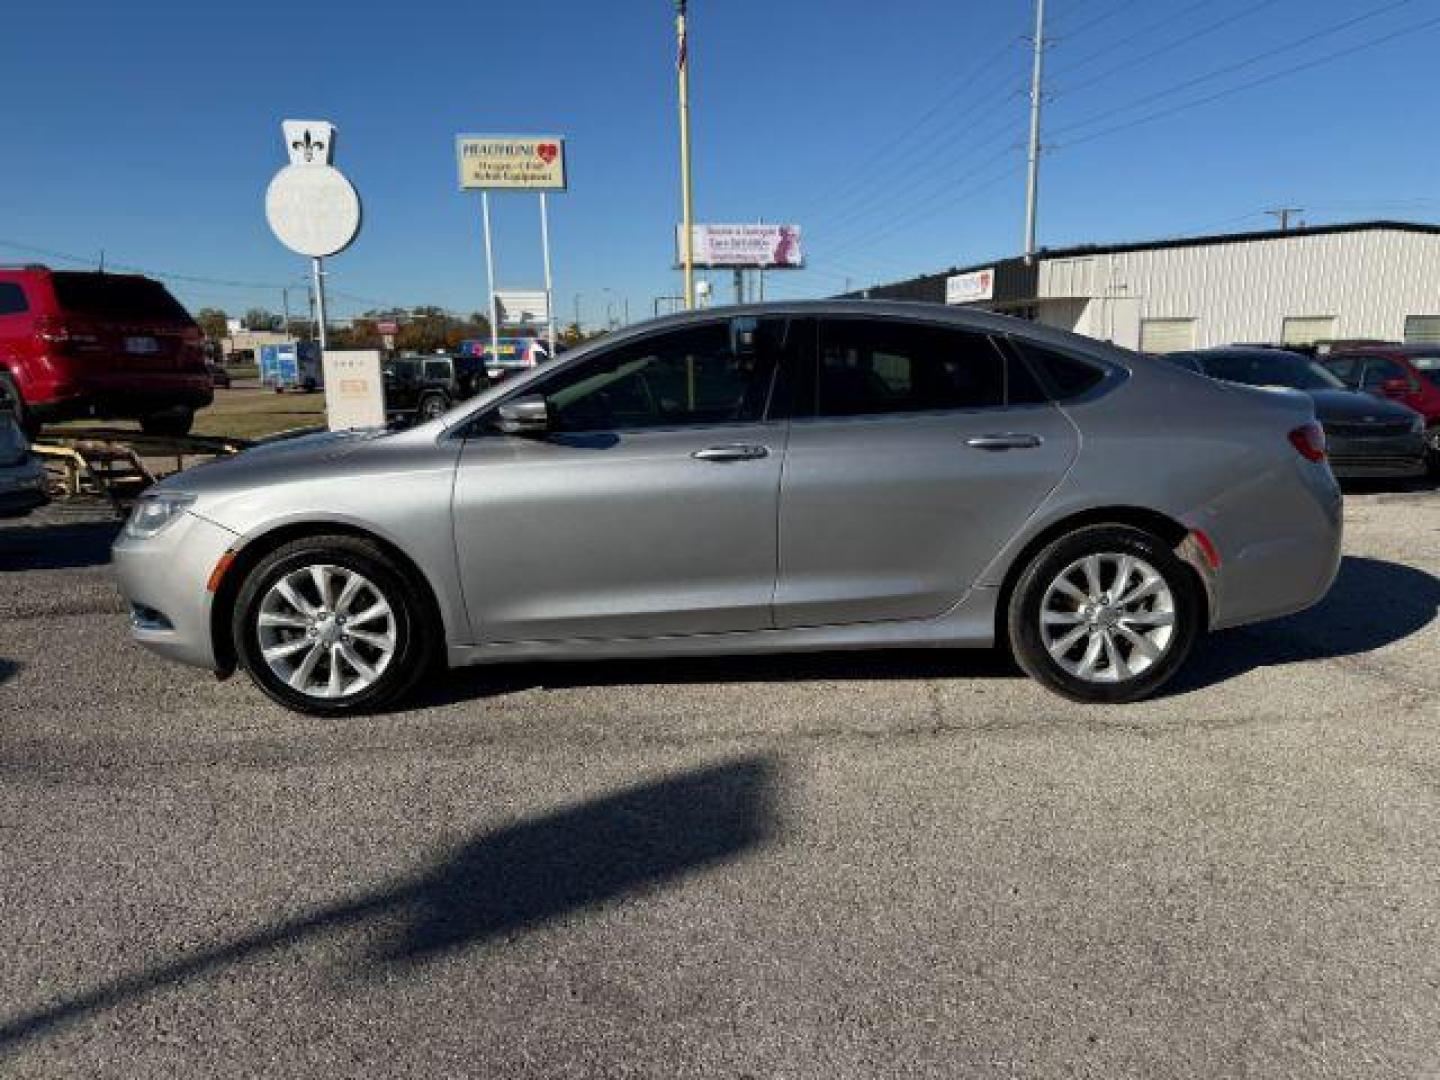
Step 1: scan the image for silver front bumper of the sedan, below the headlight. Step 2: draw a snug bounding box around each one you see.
[112,513,238,671]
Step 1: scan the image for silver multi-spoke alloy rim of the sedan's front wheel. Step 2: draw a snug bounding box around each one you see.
[256,563,397,698]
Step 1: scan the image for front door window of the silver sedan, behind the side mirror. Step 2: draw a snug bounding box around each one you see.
[543,323,770,432]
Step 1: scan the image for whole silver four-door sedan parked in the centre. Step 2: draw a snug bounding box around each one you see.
[115,301,1341,714]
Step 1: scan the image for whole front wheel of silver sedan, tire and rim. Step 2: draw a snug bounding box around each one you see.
[232,536,435,716]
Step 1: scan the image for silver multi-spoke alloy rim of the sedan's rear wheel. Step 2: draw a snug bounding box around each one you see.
[1040,552,1175,683]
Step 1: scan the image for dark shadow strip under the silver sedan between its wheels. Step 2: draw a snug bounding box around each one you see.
[410,648,1021,708]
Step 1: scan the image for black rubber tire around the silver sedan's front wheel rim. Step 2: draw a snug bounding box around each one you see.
[230,536,439,716]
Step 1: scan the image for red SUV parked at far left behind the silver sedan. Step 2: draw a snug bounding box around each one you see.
[0,266,215,438]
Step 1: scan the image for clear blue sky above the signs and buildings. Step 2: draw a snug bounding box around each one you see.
[0,0,1440,323]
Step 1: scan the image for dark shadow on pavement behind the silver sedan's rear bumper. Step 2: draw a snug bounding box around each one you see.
[1162,556,1440,694]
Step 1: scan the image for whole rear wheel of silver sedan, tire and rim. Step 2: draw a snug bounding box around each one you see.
[1008,526,1204,703]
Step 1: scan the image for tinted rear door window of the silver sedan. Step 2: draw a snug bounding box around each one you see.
[815,320,1007,416]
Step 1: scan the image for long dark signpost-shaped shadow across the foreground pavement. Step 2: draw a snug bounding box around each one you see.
[0,756,779,1056]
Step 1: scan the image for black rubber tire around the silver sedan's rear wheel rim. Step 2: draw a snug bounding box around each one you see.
[1007,524,1205,704]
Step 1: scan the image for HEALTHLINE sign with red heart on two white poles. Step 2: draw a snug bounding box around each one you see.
[455,135,566,360]
